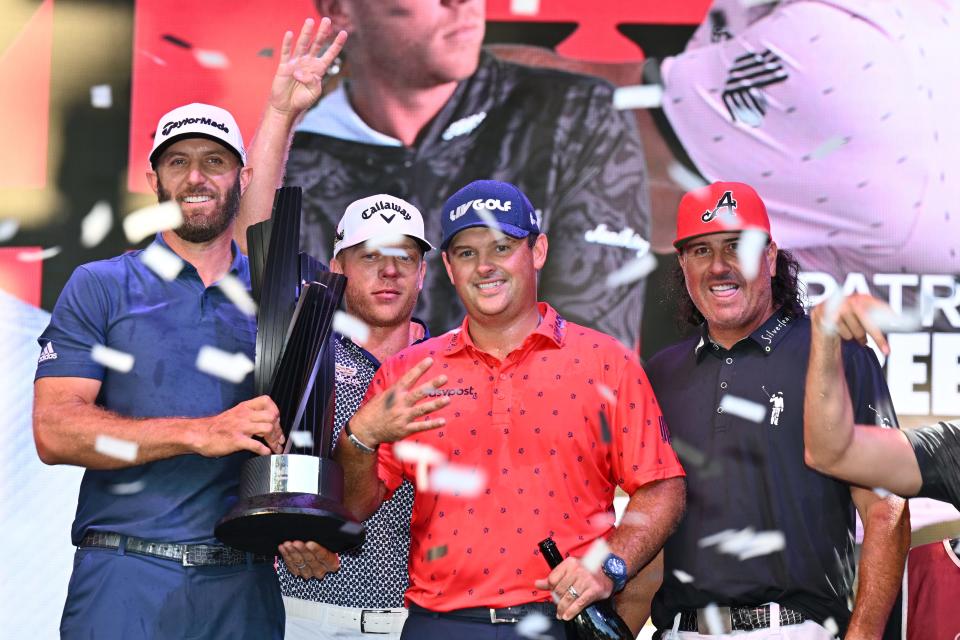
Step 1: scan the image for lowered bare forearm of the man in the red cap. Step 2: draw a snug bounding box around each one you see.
[844,487,910,640]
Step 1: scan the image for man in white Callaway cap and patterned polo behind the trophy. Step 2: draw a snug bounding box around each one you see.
[279,195,432,640]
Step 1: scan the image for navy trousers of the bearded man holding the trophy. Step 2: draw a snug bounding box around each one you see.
[60,548,285,640]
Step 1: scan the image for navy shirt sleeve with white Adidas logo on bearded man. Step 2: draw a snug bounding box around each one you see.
[35,266,110,381]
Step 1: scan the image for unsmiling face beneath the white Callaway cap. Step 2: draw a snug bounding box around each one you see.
[330,236,427,328]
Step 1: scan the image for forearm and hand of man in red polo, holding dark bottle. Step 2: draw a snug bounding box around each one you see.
[535,478,686,620]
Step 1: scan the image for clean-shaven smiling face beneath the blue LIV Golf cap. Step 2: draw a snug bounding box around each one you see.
[443,227,547,325]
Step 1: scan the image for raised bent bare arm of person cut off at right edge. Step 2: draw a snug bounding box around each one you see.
[803,295,922,496]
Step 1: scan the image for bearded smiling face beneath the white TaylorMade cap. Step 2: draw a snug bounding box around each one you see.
[147,138,250,243]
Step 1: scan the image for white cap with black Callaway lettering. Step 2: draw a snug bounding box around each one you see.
[333,194,433,258]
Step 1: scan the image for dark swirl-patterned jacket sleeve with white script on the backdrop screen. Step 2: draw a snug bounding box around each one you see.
[534,82,650,346]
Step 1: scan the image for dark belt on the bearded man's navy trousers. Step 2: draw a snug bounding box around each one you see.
[79,531,274,567]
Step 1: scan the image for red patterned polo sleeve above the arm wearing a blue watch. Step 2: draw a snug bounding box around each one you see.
[608,356,686,495]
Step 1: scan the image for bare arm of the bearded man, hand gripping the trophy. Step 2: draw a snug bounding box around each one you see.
[33,377,284,469]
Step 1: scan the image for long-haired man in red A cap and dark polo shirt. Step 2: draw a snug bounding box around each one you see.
[647,182,909,640]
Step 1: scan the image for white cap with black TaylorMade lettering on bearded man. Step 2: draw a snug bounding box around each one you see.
[150,102,247,166]
